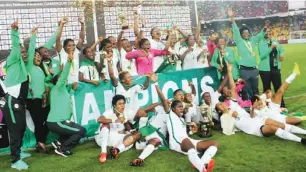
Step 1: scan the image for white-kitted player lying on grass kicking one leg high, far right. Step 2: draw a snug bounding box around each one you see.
[251,64,305,125]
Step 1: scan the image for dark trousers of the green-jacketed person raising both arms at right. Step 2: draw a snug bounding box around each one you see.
[240,67,259,100]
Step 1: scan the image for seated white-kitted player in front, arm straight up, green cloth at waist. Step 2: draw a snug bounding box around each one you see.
[130,75,170,166]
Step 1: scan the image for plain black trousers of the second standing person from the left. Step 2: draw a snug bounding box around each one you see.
[27,99,50,143]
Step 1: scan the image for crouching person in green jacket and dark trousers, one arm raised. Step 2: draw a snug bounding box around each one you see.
[47,51,86,157]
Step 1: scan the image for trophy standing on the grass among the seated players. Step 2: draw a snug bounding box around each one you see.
[198,104,213,138]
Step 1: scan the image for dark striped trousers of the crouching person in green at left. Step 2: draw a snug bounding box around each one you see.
[47,121,86,151]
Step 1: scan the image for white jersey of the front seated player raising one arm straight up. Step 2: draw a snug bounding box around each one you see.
[148,106,168,137]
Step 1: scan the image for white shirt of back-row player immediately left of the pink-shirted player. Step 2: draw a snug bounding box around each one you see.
[120,48,138,76]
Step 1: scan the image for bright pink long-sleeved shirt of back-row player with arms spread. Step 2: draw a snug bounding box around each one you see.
[125,49,169,75]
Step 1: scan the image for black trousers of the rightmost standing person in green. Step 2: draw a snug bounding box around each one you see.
[259,69,285,107]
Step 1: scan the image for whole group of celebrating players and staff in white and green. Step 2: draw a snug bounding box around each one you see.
[0,9,306,172]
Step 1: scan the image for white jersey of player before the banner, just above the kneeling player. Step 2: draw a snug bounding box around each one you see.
[116,82,143,110]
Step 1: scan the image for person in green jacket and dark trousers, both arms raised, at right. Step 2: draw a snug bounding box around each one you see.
[228,8,269,100]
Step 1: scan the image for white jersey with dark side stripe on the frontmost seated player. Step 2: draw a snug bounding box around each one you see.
[167,111,188,145]
